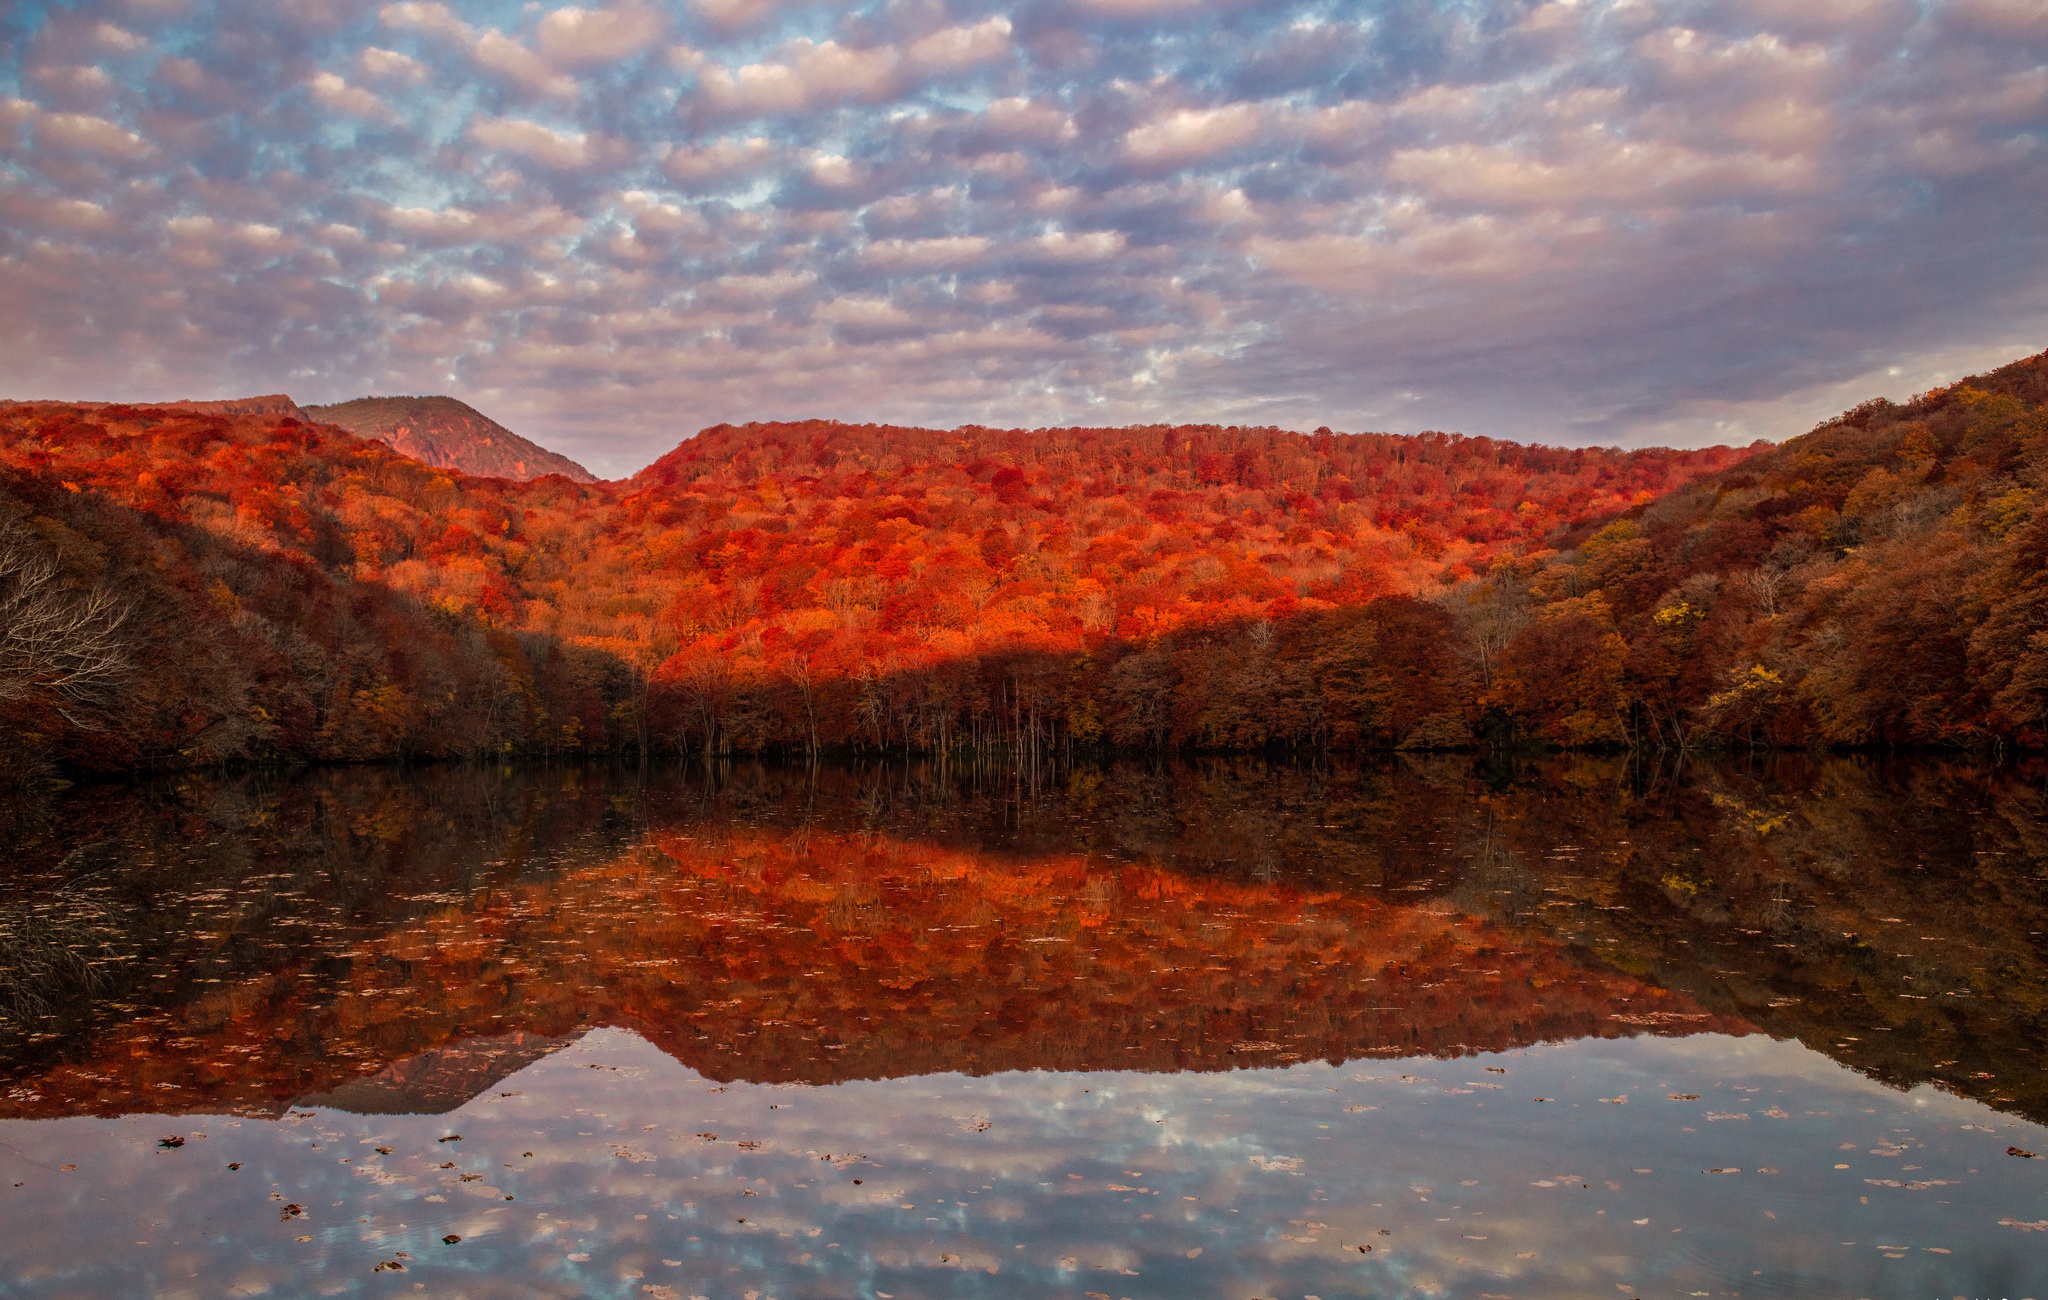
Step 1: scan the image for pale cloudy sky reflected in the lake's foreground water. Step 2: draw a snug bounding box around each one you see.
[0,1030,2048,1300]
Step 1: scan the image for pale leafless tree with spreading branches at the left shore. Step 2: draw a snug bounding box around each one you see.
[0,516,129,729]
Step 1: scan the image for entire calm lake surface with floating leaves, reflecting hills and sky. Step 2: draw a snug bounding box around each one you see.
[0,760,2048,1300]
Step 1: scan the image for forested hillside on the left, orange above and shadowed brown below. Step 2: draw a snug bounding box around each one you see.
[0,403,639,784]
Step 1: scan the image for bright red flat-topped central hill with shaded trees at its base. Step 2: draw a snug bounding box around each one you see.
[622,422,1743,747]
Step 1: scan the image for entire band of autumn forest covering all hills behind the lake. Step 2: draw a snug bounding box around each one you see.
[0,345,2048,784]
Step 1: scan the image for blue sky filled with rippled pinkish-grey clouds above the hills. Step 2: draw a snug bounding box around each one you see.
[0,0,2048,475]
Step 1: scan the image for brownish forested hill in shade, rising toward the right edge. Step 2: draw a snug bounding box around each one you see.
[1470,352,2048,747]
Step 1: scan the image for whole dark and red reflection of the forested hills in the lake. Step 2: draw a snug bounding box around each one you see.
[0,760,2048,1116]
